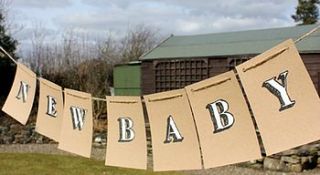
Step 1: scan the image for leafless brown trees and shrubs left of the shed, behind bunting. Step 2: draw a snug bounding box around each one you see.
[19,23,160,130]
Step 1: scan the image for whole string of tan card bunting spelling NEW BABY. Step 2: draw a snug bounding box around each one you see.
[2,35,320,171]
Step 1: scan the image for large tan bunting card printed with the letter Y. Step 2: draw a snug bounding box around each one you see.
[236,40,320,155]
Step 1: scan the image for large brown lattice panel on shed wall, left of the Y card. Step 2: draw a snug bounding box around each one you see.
[155,59,209,92]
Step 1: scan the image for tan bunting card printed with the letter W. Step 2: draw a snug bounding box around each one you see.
[58,89,93,158]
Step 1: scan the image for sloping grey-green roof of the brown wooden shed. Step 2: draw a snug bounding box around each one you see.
[140,24,320,60]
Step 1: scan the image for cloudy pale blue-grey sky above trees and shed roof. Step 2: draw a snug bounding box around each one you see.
[10,0,297,52]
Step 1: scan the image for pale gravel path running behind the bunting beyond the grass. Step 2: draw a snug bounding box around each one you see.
[0,144,320,175]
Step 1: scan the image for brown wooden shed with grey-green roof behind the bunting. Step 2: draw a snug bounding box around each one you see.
[140,25,320,94]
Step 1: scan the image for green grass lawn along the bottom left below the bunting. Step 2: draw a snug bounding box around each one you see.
[0,153,182,175]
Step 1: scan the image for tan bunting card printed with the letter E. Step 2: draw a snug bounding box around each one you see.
[36,78,63,141]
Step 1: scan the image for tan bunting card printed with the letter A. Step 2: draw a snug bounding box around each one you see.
[144,89,202,171]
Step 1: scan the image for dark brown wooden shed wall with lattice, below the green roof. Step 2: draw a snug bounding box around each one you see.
[141,54,320,95]
